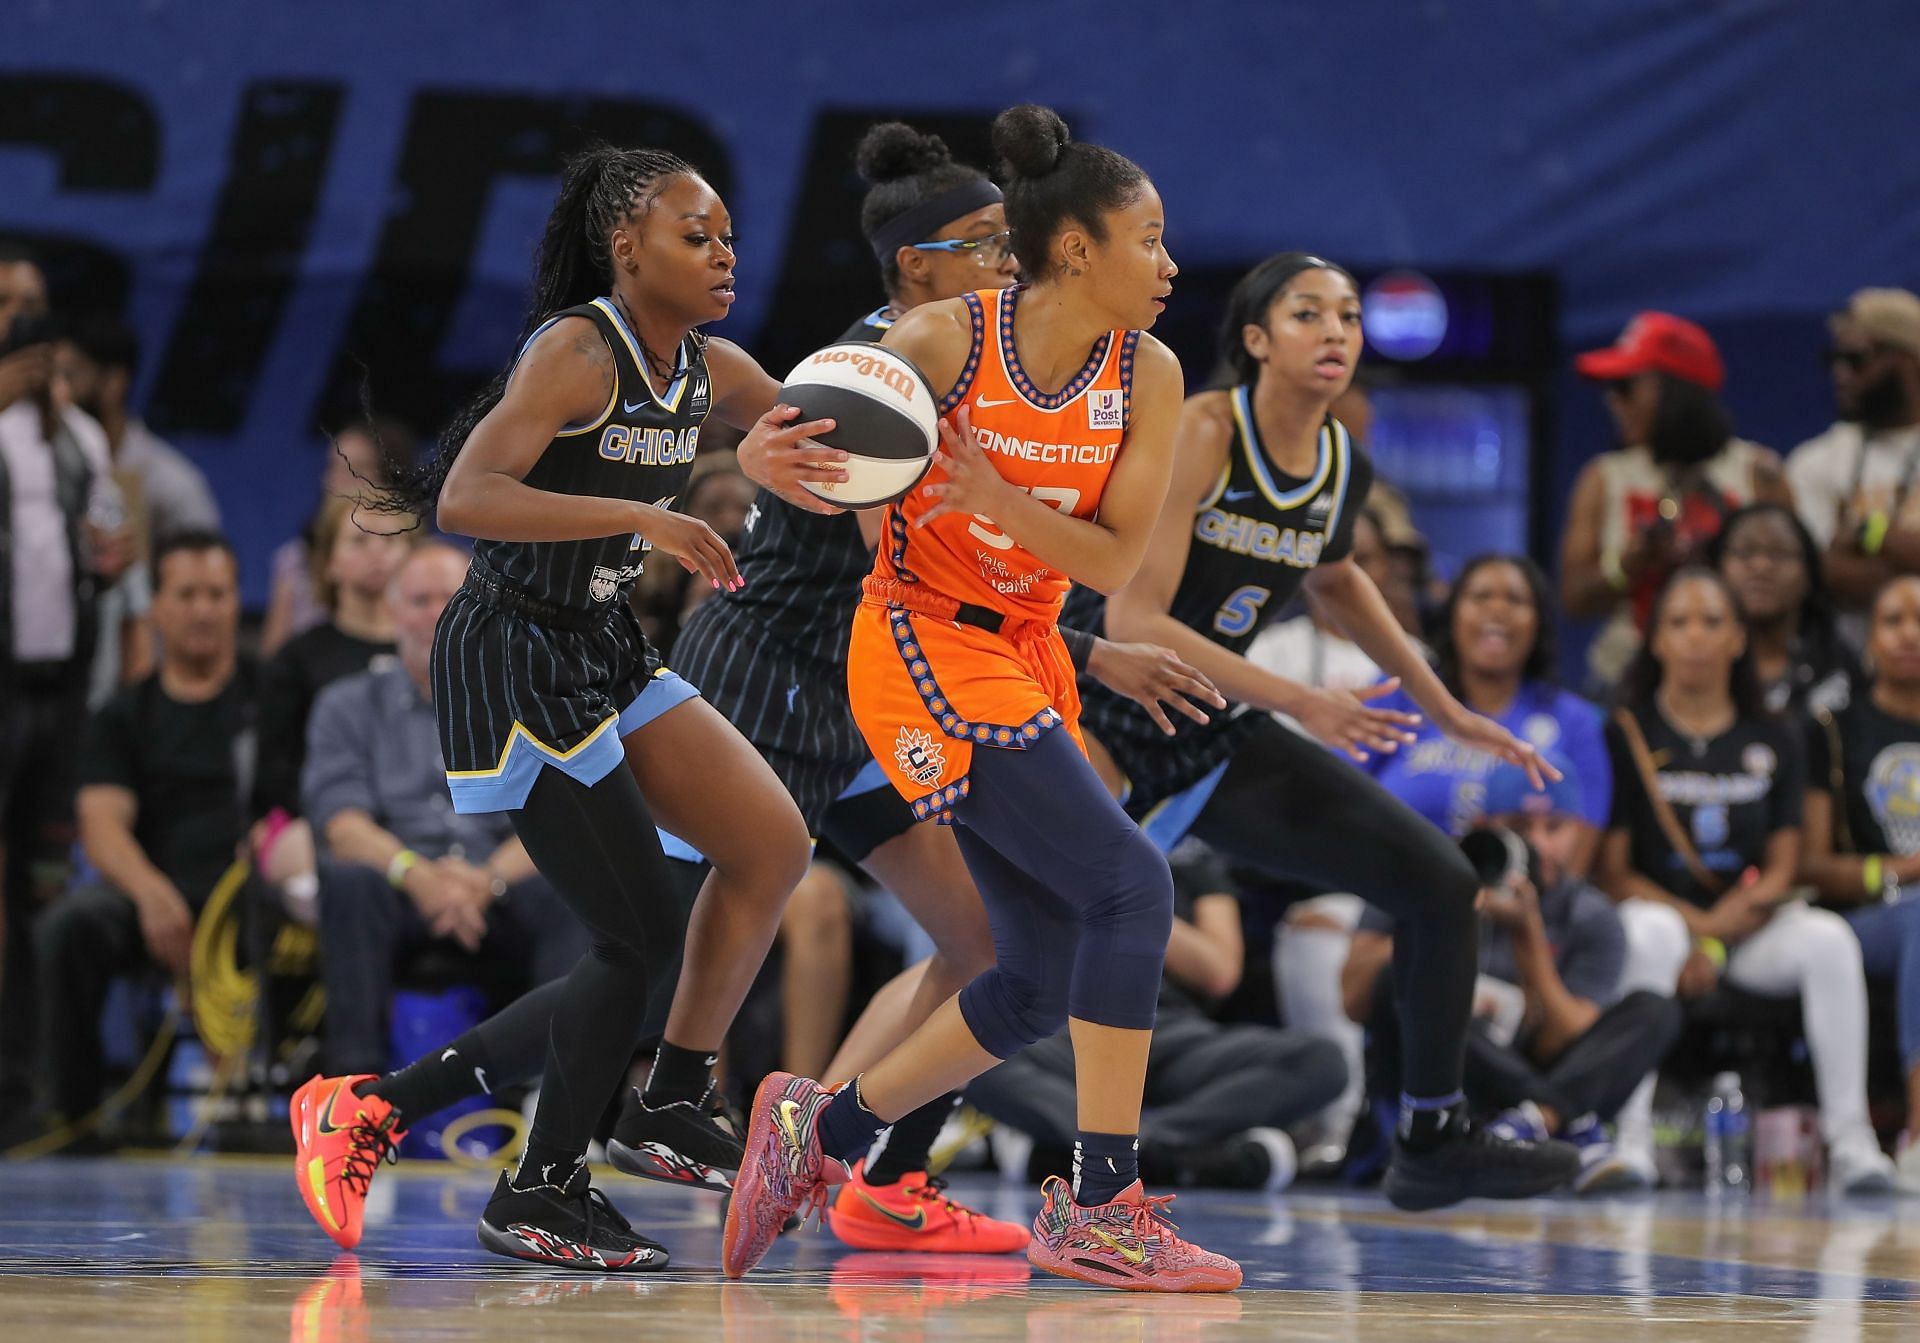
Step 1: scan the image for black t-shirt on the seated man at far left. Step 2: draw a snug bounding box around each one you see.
[81,661,257,911]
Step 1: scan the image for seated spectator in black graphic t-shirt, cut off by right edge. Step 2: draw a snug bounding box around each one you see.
[1801,574,1920,1193]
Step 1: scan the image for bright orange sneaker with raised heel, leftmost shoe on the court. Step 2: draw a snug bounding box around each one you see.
[288,1072,407,1249]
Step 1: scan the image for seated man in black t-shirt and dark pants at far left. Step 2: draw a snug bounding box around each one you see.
[38,532,255,1120]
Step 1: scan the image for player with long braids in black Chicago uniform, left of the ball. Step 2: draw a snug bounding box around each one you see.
[292,146,864,1270]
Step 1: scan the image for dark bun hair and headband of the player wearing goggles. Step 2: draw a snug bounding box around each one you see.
[854,121,1000,298]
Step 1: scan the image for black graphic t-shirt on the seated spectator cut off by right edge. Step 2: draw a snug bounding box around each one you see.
[1807,688,1920,855]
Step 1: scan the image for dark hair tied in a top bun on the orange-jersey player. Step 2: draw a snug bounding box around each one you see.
[993,104,1146,281]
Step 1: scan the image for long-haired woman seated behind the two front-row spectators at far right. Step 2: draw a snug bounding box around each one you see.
[1707,503,1860,715]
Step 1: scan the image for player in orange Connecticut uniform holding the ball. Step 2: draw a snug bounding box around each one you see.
[722,106,1240,1291]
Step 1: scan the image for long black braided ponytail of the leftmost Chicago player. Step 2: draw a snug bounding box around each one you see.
[363,144,699,517]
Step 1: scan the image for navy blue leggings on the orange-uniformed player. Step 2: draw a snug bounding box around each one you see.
[954,730,1173,1059]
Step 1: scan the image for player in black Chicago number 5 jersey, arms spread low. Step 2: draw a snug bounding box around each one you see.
[1066,252,1578,1209]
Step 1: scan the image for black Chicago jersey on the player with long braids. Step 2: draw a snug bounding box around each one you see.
[474,298,712,611]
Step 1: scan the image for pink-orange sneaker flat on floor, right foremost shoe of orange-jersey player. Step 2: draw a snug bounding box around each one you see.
[1027,1176,1240,1291]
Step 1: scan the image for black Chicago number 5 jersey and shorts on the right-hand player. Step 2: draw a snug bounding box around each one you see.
[1060,386,1373,809]
